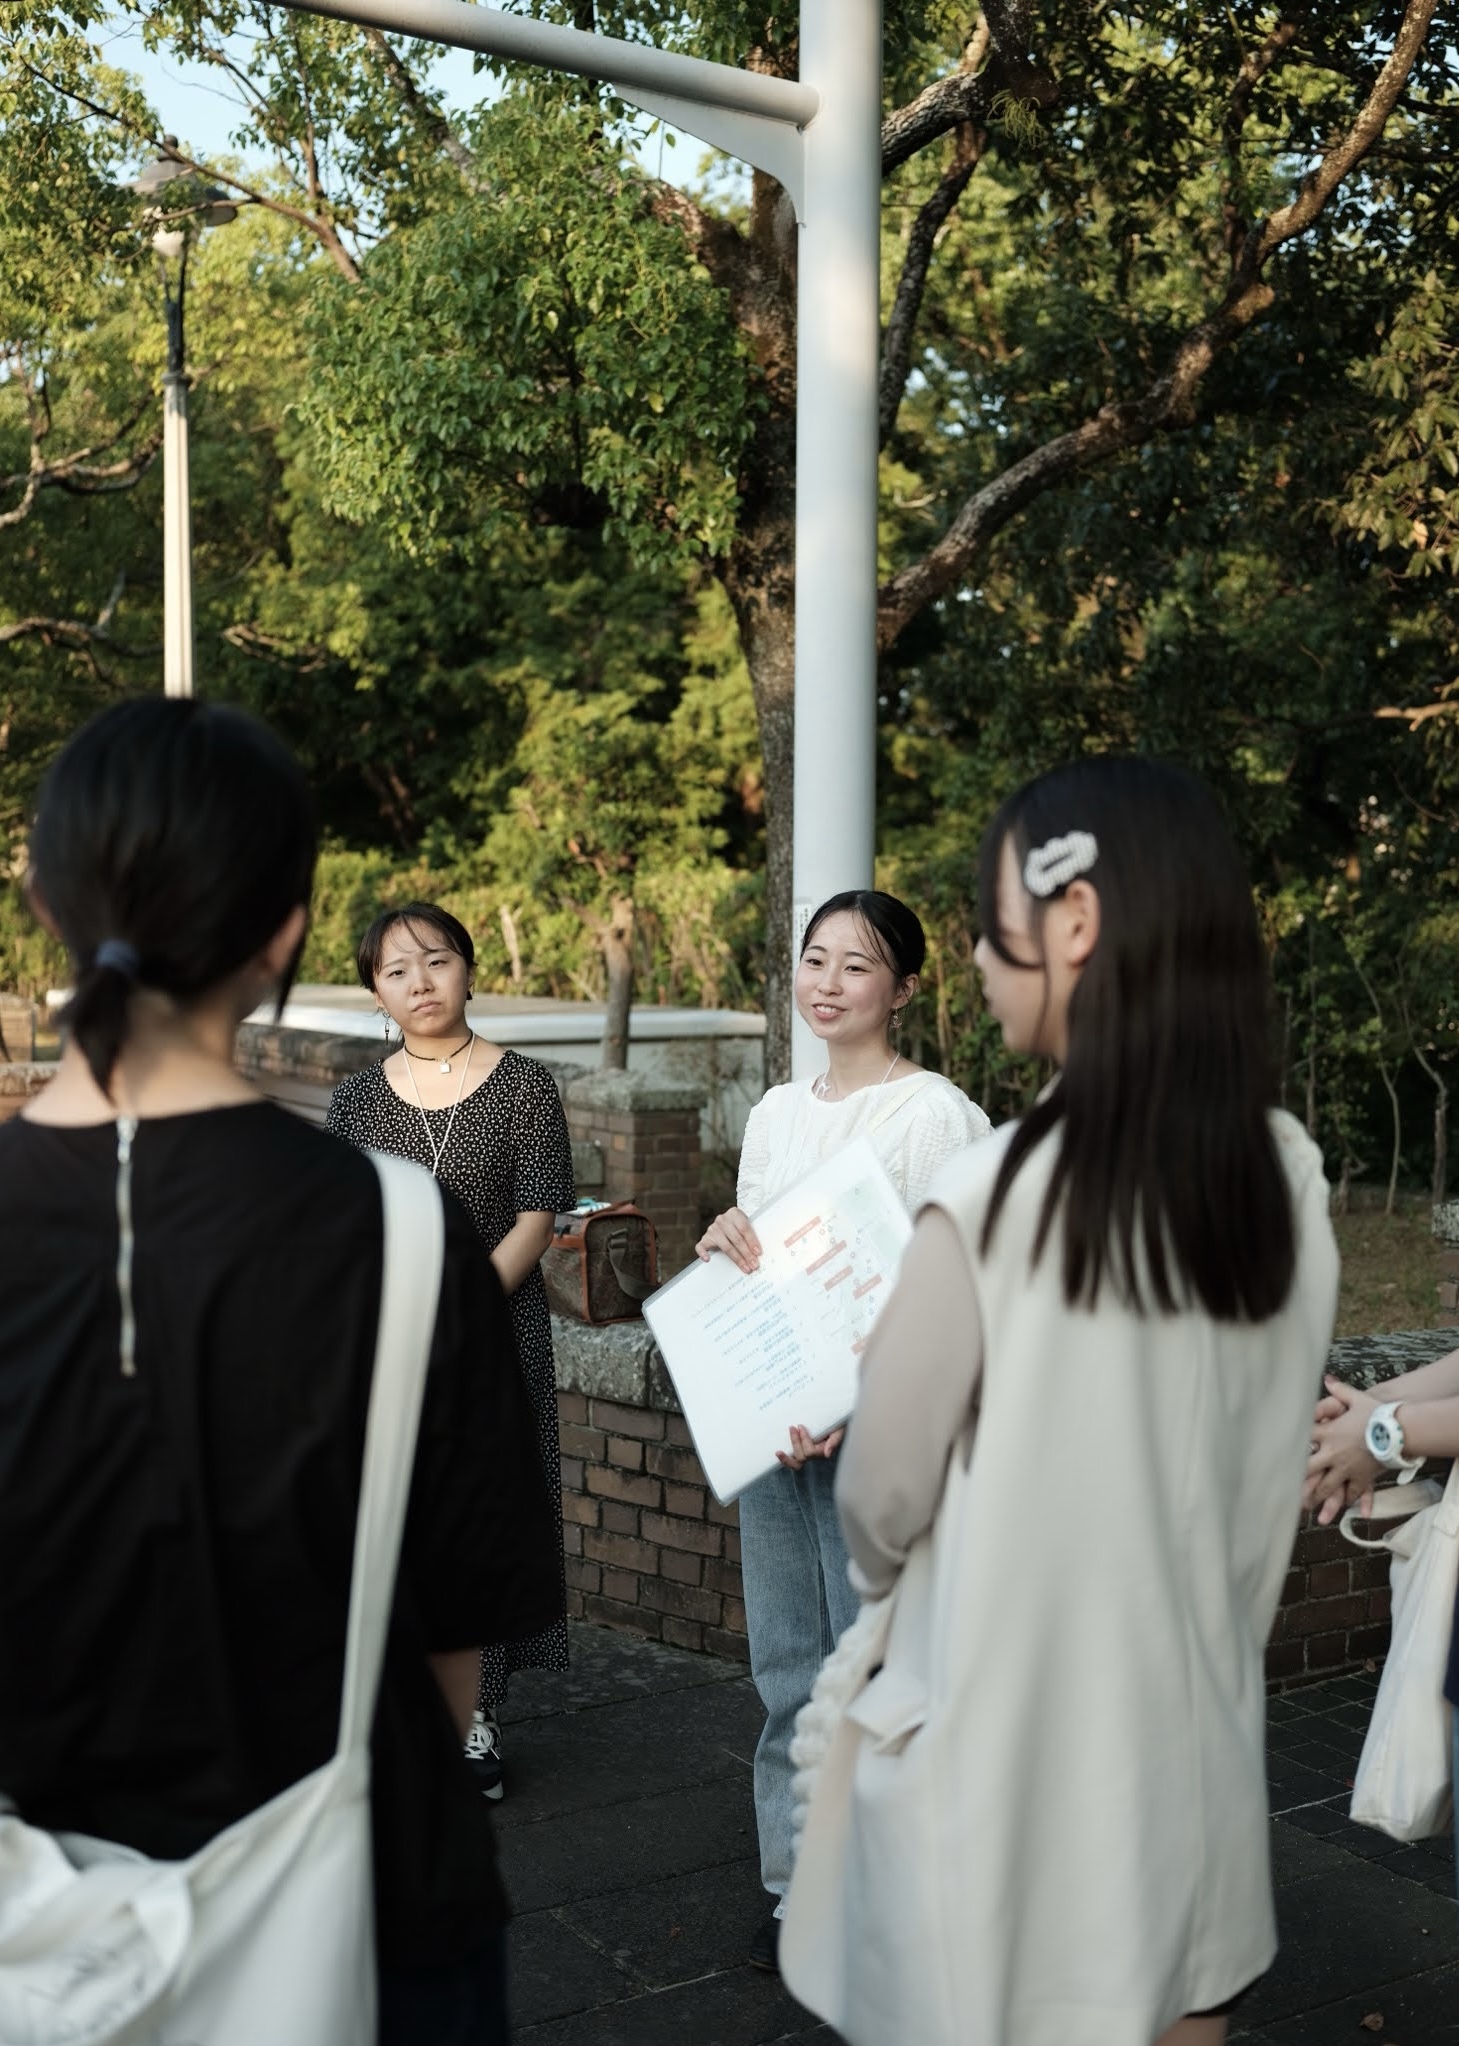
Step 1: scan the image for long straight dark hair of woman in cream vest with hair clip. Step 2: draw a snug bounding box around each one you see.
[978,757,1295,1322]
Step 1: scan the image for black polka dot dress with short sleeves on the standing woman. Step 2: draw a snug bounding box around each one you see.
[329,1052,573,1704]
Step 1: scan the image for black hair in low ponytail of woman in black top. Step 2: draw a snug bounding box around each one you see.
[31,696,315,1095]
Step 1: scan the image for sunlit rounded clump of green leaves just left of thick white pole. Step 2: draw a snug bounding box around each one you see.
[301,100,749,565]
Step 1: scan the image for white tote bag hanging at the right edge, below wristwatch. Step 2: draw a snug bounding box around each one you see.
[1342,1463,1459,1839]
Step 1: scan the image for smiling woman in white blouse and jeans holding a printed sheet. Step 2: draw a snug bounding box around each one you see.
[696,888,990,1968]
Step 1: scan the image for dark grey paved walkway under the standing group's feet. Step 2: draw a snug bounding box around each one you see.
[497,1627,1459,2046]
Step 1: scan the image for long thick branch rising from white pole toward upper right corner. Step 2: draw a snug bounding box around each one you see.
[878,0,1439,651]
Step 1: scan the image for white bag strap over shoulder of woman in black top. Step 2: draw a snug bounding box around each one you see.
[340,1152,446,1755]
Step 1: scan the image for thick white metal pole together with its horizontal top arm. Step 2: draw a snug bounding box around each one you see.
[263,0,882,1078]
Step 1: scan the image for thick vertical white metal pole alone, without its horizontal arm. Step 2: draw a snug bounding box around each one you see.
[792,0,882,1078]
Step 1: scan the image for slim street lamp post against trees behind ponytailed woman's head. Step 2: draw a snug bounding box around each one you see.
[135,135,237,696]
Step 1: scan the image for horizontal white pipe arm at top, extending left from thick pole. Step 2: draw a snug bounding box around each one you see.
[268,0,821,127]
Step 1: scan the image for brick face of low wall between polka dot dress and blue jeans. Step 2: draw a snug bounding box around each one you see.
[557,1391,749,1659]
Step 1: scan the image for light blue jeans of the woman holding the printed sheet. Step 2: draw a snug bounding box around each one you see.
[739,1457,859,1897]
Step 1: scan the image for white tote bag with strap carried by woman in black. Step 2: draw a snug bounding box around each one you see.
[0,1156,444,2046]
